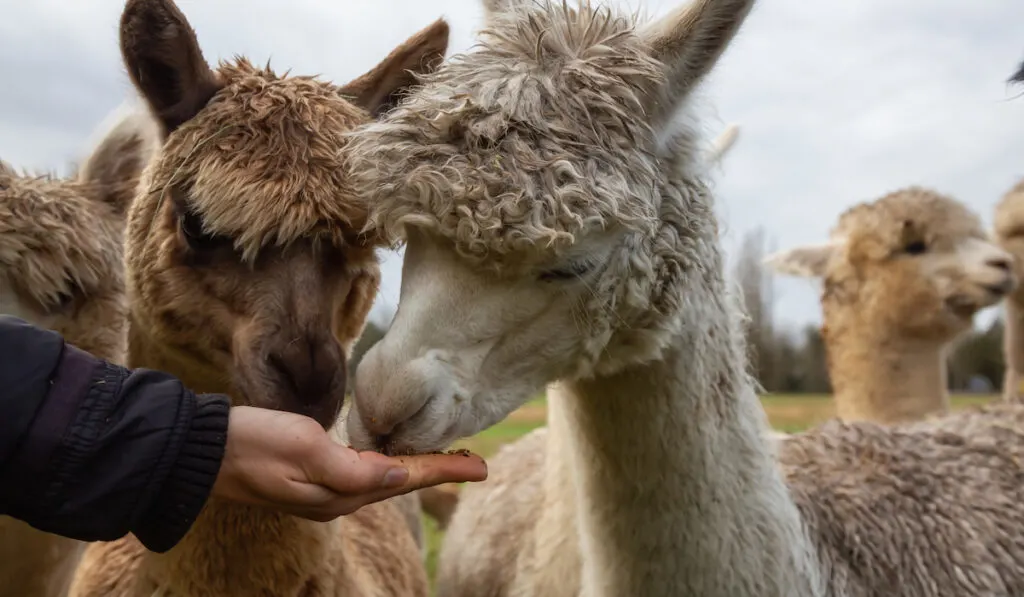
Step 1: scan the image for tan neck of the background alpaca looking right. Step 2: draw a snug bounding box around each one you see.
[826,326,949,424]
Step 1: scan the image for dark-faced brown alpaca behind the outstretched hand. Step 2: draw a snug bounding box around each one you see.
[64,0,449,597]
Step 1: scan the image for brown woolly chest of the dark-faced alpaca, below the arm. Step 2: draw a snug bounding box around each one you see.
[71,500,427,597]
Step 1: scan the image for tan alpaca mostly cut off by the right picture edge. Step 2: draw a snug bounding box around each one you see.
[994,176,1024,402]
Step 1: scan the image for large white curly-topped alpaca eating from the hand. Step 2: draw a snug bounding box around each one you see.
[337,0,1024,597]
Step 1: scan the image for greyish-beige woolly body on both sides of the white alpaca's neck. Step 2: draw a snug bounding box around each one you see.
[437,395,1024,597]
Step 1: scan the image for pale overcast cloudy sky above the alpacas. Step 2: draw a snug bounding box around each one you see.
[0,0,1024,333]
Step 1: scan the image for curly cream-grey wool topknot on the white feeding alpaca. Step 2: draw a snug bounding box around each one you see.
[349,4,664,267]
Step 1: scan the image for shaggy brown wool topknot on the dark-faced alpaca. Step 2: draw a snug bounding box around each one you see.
[147,57,376,261]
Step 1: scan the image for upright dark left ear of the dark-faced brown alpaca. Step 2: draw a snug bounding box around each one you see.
[120,0,221,134]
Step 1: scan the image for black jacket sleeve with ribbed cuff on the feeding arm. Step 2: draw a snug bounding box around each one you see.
[0,315,229,552]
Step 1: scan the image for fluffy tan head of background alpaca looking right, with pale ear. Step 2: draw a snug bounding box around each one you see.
[766,186,1017,343]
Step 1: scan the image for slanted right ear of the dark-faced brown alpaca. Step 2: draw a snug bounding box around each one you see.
[340,18,449,117]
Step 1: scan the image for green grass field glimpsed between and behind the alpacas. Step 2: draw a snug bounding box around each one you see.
[424,394,996,580]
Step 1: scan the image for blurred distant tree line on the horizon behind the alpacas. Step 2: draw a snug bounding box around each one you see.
[349,228,1005,393]
